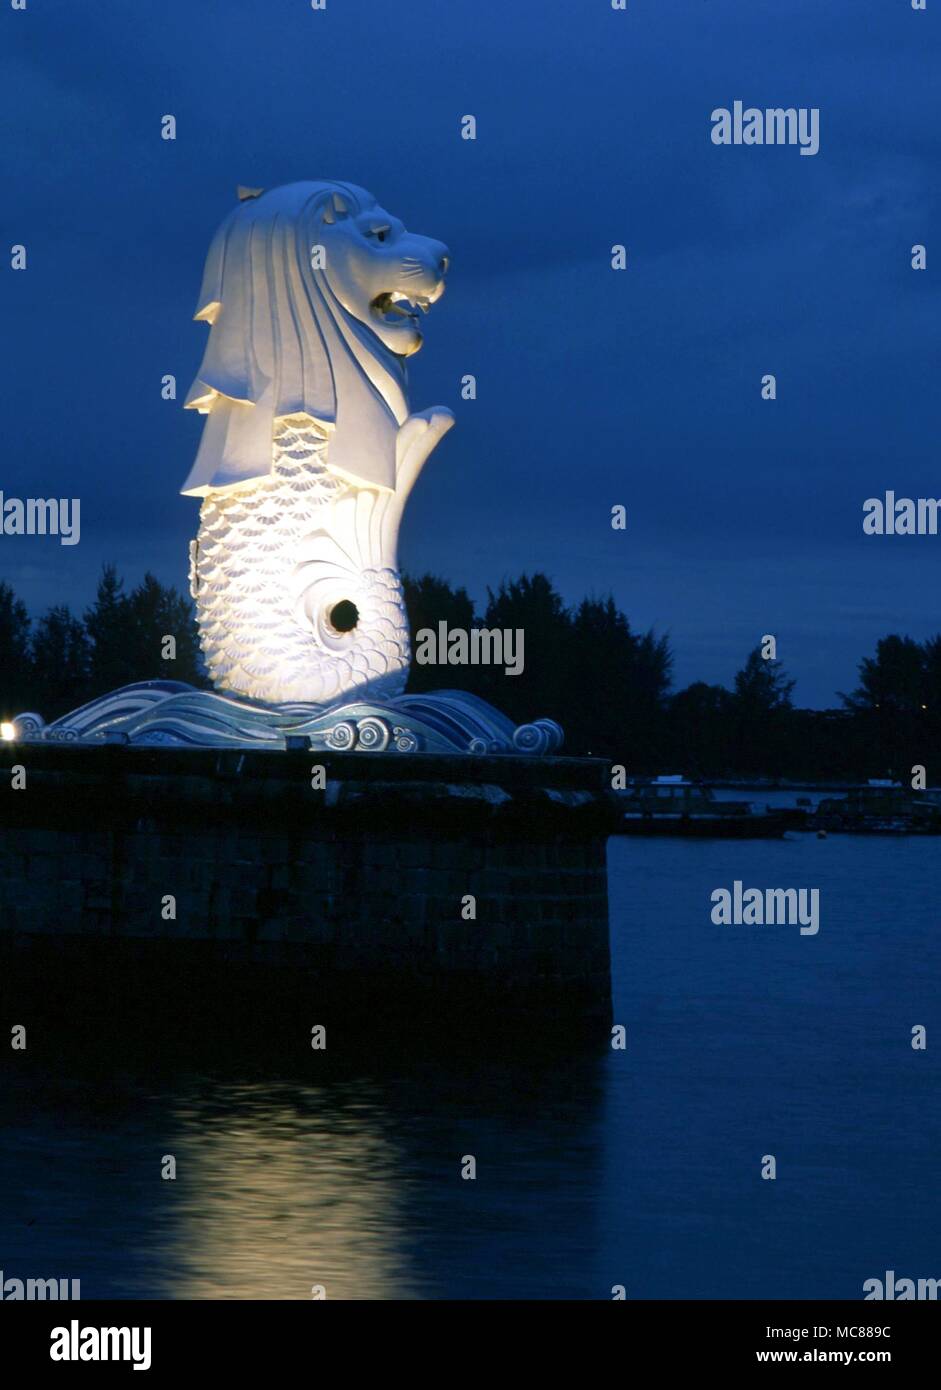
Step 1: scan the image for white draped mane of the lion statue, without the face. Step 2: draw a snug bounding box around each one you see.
[181,182,409,496]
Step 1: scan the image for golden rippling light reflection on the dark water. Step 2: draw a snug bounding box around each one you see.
[160,1083,414,1298]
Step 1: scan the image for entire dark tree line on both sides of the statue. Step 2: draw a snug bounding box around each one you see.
[0,566,941,784]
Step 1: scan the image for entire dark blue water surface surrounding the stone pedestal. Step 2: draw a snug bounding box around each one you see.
[0,834,941,1298]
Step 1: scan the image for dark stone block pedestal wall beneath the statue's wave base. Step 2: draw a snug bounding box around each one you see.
[0,744,614,1037]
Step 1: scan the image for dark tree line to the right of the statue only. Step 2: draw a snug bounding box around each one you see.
[404,574,941,784]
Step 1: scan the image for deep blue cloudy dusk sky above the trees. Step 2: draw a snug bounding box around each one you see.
[0,0,941,705]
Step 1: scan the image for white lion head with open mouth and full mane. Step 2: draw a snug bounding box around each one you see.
[182,182,448,496]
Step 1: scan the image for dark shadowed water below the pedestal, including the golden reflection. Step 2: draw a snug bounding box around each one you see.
[0,1047,605,1300]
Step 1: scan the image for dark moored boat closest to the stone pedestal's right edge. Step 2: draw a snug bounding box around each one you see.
[617,776,788,840]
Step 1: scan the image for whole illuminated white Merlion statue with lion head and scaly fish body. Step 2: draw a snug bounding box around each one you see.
[182,182,455,706]
